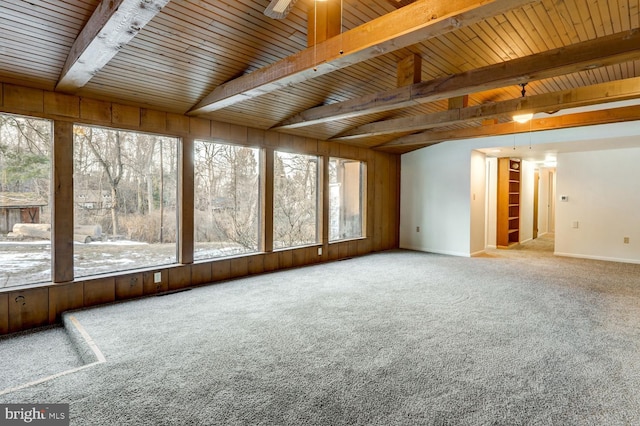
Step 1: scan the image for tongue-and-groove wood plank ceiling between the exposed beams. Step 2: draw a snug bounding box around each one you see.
[0,0,640,149]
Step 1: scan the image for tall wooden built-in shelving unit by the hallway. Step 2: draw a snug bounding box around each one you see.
[496,158,521,248]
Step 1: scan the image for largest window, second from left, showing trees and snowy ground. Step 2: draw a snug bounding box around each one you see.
[73,125,179,277]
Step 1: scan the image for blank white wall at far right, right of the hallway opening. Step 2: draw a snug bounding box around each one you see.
[555,148,640,263]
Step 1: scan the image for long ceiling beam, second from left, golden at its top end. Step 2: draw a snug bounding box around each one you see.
[188,0,540,115]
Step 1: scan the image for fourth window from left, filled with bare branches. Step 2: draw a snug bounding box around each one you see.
[273,151,318,249]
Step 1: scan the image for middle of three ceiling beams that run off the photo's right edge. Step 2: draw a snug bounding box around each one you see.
[330,77,640,141]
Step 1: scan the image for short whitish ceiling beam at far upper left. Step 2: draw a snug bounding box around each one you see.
[56,0,169,91]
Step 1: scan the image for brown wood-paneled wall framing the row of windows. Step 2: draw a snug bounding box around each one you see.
[0,83,400,334]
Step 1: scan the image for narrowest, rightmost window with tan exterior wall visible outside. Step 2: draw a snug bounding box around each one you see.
[329,157,366,241]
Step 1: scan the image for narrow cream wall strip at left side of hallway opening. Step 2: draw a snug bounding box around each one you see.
[469,151,487,256]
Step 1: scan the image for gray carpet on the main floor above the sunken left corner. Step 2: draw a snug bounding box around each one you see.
[0,235,640,425]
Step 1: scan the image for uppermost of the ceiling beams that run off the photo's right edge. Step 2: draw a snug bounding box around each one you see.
[272,29,640,130]
